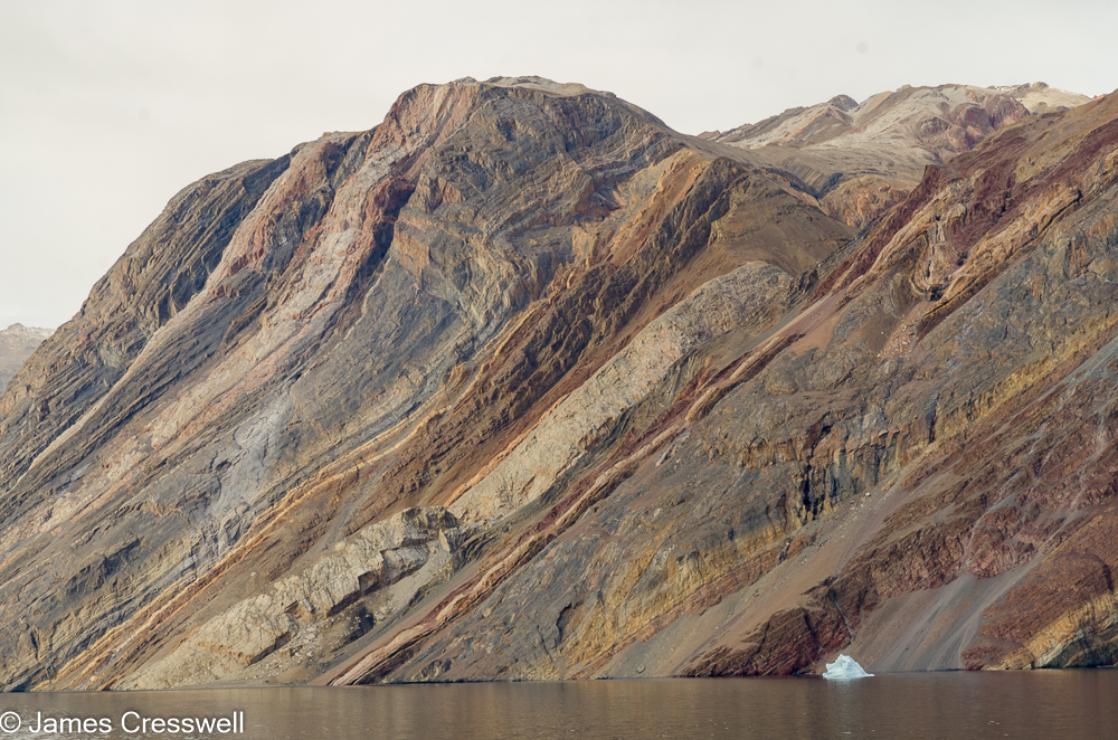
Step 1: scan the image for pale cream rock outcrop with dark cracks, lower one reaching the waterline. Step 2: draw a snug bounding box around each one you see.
[120,509,464,689]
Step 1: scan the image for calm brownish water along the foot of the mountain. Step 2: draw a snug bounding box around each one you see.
[0,671,1118,740]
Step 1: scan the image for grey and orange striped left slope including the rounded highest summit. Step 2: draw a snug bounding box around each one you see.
[0,75,847,685]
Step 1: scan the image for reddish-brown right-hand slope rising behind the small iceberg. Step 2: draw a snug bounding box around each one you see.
[330,85,1118,682]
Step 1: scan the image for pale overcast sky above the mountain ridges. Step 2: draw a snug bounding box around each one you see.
[0,0,1118,326]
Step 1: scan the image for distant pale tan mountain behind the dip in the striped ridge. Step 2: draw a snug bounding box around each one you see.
[703,83,1090,228]
